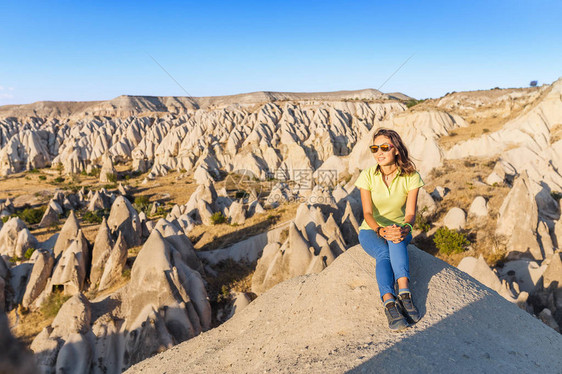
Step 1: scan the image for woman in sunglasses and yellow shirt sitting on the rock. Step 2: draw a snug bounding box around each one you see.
[355,128,424,330]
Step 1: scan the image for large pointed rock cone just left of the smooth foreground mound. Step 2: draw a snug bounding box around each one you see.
[124,230,211,366]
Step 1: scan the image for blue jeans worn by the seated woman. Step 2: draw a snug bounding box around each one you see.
[359,230,412,300]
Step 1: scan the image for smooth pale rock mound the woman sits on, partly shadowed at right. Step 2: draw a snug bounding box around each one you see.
[124,246,562,373]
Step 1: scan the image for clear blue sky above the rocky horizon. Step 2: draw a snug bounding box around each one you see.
[0,0,562,105]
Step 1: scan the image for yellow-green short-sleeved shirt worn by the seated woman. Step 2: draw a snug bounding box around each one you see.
[355,165,425,230]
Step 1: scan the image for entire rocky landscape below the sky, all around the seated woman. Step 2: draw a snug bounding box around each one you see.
[0,79,562,373]
